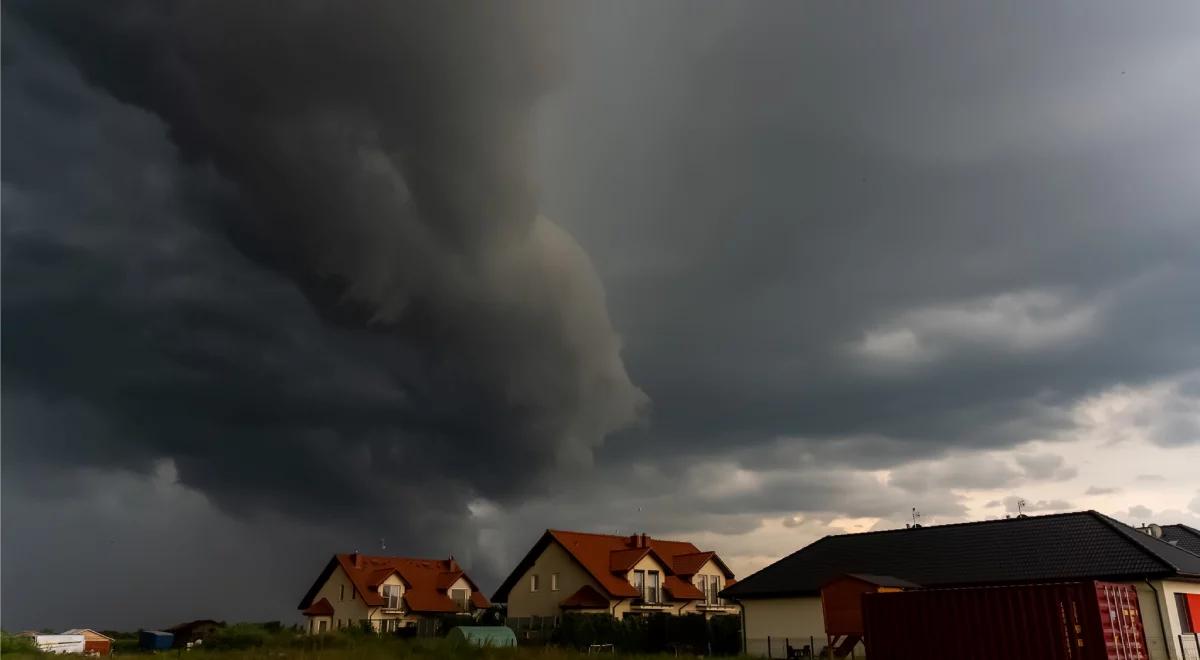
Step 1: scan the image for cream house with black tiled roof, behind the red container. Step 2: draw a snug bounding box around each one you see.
[722,511,1200,660]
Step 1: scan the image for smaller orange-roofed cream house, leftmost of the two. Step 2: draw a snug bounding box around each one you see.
[300,552,491,635]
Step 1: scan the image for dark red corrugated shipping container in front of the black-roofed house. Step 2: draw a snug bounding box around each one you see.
[863,582,1150,660]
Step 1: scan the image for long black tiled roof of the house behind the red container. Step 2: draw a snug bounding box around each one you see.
[724,511,1200,598]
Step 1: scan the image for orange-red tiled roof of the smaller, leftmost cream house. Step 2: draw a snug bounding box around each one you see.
[300,554,490,612]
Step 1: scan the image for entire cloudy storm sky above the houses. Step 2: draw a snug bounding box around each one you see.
[0,1,1200,630]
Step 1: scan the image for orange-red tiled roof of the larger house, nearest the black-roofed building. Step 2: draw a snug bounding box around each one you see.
[494,529,733,602]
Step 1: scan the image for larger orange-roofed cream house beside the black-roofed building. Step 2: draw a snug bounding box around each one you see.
[492,529,736,619]
